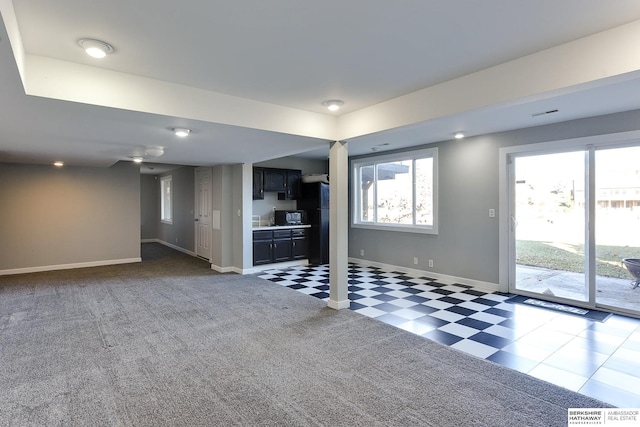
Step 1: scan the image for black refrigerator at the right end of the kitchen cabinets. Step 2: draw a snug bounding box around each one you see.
[297,182,329,265]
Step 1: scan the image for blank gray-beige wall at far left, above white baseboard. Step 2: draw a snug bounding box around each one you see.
[0,162,140,270]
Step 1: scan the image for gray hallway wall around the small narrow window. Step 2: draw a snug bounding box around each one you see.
[156,166,195,252]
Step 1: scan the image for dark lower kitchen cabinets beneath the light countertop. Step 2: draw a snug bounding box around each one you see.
[253,228,307,265]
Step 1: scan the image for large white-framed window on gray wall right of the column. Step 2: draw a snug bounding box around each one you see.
[351,148,438,234]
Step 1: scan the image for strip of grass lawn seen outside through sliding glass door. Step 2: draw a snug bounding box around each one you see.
[516,240,640,279]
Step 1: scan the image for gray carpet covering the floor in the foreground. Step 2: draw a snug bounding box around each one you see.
[0,244,610,427]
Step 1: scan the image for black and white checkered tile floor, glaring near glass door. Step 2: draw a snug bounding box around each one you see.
[259,264,640,408]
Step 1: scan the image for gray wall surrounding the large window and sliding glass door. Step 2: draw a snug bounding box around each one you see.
[349,110,640,283]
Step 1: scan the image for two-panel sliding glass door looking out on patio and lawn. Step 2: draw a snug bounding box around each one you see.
[509,146,640,314]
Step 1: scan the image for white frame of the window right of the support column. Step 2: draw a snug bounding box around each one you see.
[350,147,438,234]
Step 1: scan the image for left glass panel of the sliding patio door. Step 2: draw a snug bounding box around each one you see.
[512,151,589,302]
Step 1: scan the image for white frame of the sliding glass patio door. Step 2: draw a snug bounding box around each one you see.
[498,131,640,316]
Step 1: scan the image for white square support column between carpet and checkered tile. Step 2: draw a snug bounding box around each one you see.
[328,141,351,310]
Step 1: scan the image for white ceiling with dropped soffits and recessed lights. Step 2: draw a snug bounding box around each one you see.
[0,0,640,172]
